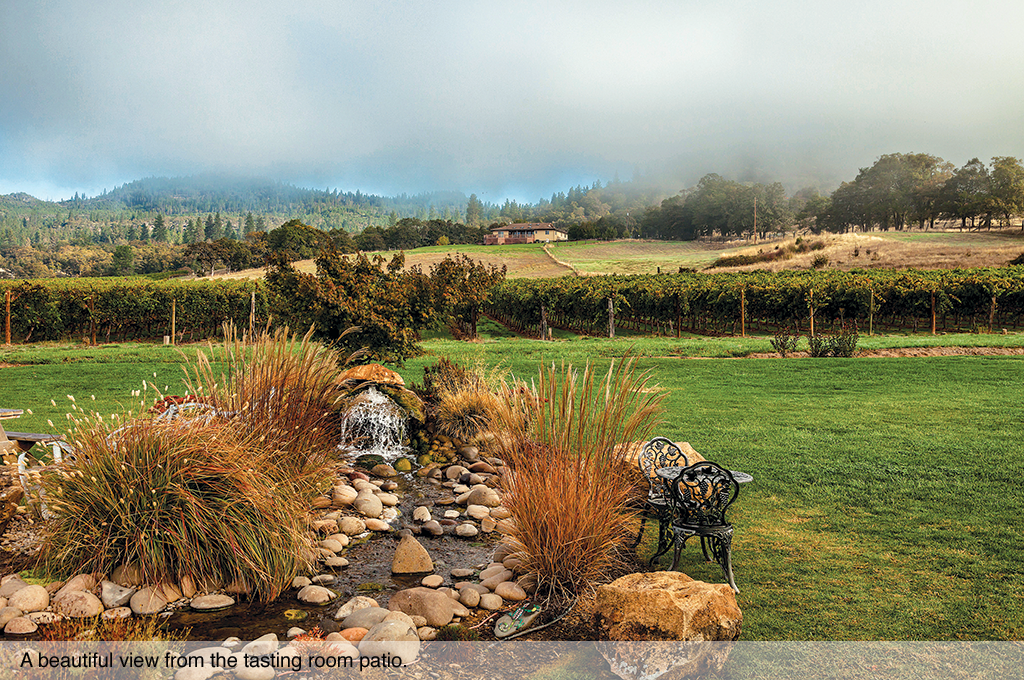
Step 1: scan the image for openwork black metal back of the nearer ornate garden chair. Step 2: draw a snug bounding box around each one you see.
[670,461,739,533]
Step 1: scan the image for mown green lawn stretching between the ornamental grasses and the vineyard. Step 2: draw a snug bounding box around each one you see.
[0,327,1024,640]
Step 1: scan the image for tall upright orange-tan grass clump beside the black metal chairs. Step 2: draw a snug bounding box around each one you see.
[495,359,665,597]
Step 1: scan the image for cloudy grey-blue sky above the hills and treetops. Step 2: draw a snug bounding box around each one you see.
[0,0,1024,203]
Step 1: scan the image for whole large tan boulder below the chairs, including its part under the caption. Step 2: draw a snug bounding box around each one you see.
[594,571,743,680]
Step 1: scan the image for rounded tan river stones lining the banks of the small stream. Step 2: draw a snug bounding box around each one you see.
[0,445,535,643]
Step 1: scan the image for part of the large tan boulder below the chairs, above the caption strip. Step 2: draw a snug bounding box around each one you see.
[594,571,743,641]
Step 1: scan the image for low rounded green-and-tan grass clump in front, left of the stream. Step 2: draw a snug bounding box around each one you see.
[43,419,311,601]
